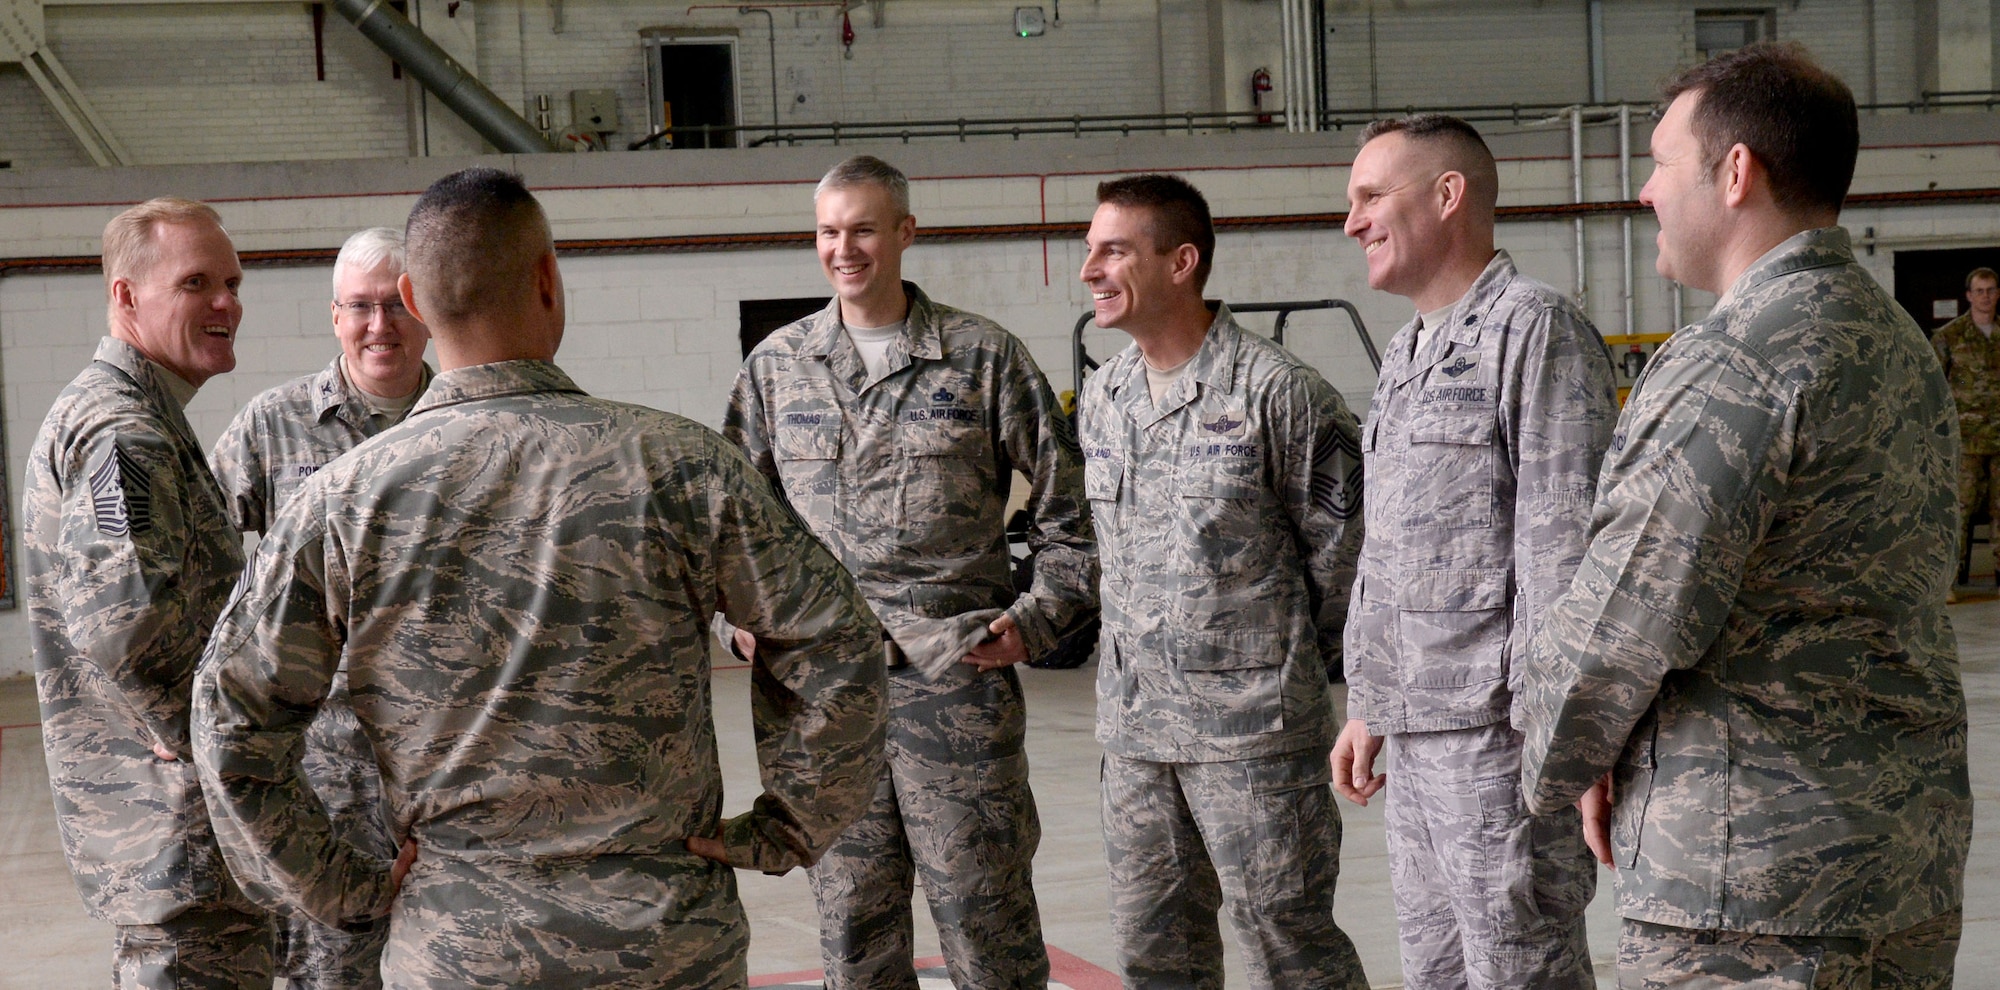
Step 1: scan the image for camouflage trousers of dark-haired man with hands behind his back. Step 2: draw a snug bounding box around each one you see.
[1104,750,1368,990]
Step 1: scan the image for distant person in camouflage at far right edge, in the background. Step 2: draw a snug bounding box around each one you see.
[1930,268,2000,584]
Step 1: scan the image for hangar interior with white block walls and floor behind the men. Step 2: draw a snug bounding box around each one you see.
[0,0,2000,986]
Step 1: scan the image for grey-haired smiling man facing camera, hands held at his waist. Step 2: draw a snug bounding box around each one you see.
[724,156,1096,990]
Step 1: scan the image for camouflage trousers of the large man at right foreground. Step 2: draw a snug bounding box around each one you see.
[1618,910,1964,990]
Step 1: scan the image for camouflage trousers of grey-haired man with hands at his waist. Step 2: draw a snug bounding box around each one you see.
[806,664,1048,990]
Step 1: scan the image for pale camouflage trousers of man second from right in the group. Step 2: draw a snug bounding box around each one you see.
[1382,722,1598,990]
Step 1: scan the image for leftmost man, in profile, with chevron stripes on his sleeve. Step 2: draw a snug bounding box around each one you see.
[22,198,270,990]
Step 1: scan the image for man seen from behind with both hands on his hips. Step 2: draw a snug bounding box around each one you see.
[194,168,882,988]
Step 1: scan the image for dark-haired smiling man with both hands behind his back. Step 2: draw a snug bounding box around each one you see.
[1078,176,1368,990]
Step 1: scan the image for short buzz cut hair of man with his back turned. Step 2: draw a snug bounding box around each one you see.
[404,168,556,328]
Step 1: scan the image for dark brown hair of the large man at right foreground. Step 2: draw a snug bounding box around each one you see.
[1660,42,1860,214]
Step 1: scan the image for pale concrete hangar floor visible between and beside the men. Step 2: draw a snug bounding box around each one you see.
[0,596,2000,988]
